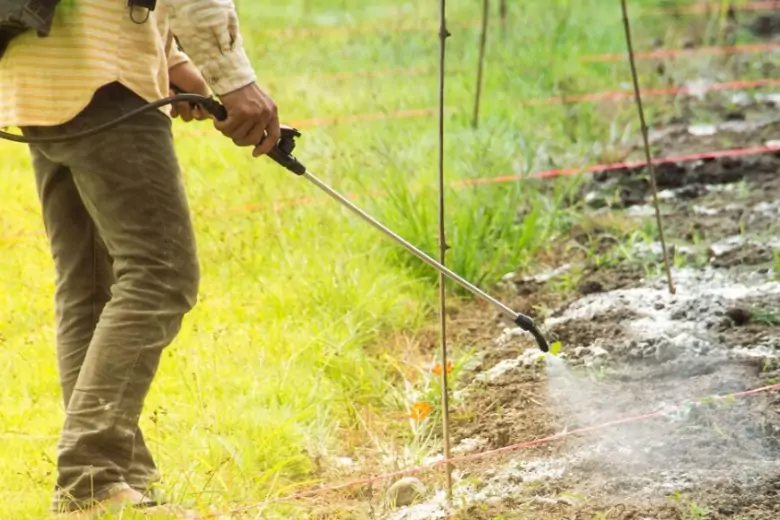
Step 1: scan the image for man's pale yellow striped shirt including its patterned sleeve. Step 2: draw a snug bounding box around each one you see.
[0,0,255,127]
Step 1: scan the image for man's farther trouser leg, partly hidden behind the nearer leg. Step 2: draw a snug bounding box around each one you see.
[31,153,165,504]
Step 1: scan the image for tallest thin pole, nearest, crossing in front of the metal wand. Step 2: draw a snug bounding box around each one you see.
[439,0,452,501]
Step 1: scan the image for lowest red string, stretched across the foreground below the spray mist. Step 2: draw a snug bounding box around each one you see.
[206,383,780,518]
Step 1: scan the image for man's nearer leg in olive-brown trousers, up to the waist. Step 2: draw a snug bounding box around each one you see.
[25,85,199,509]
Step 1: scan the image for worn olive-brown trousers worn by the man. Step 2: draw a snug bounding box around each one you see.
[22,84,200,511]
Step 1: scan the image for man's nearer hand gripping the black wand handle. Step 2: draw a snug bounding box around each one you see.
[214,83,281,157]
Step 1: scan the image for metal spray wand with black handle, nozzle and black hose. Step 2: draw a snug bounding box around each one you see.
[0,89,549,352]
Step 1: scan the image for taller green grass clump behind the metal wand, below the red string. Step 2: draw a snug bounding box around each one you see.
[368,176,577,294]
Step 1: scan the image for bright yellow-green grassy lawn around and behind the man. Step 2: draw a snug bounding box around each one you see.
[0,0,760,520]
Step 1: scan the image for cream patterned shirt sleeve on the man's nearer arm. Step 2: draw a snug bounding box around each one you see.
[165,0,256,96]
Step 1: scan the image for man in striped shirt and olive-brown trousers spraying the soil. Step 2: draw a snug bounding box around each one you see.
[0,0,279,518]
